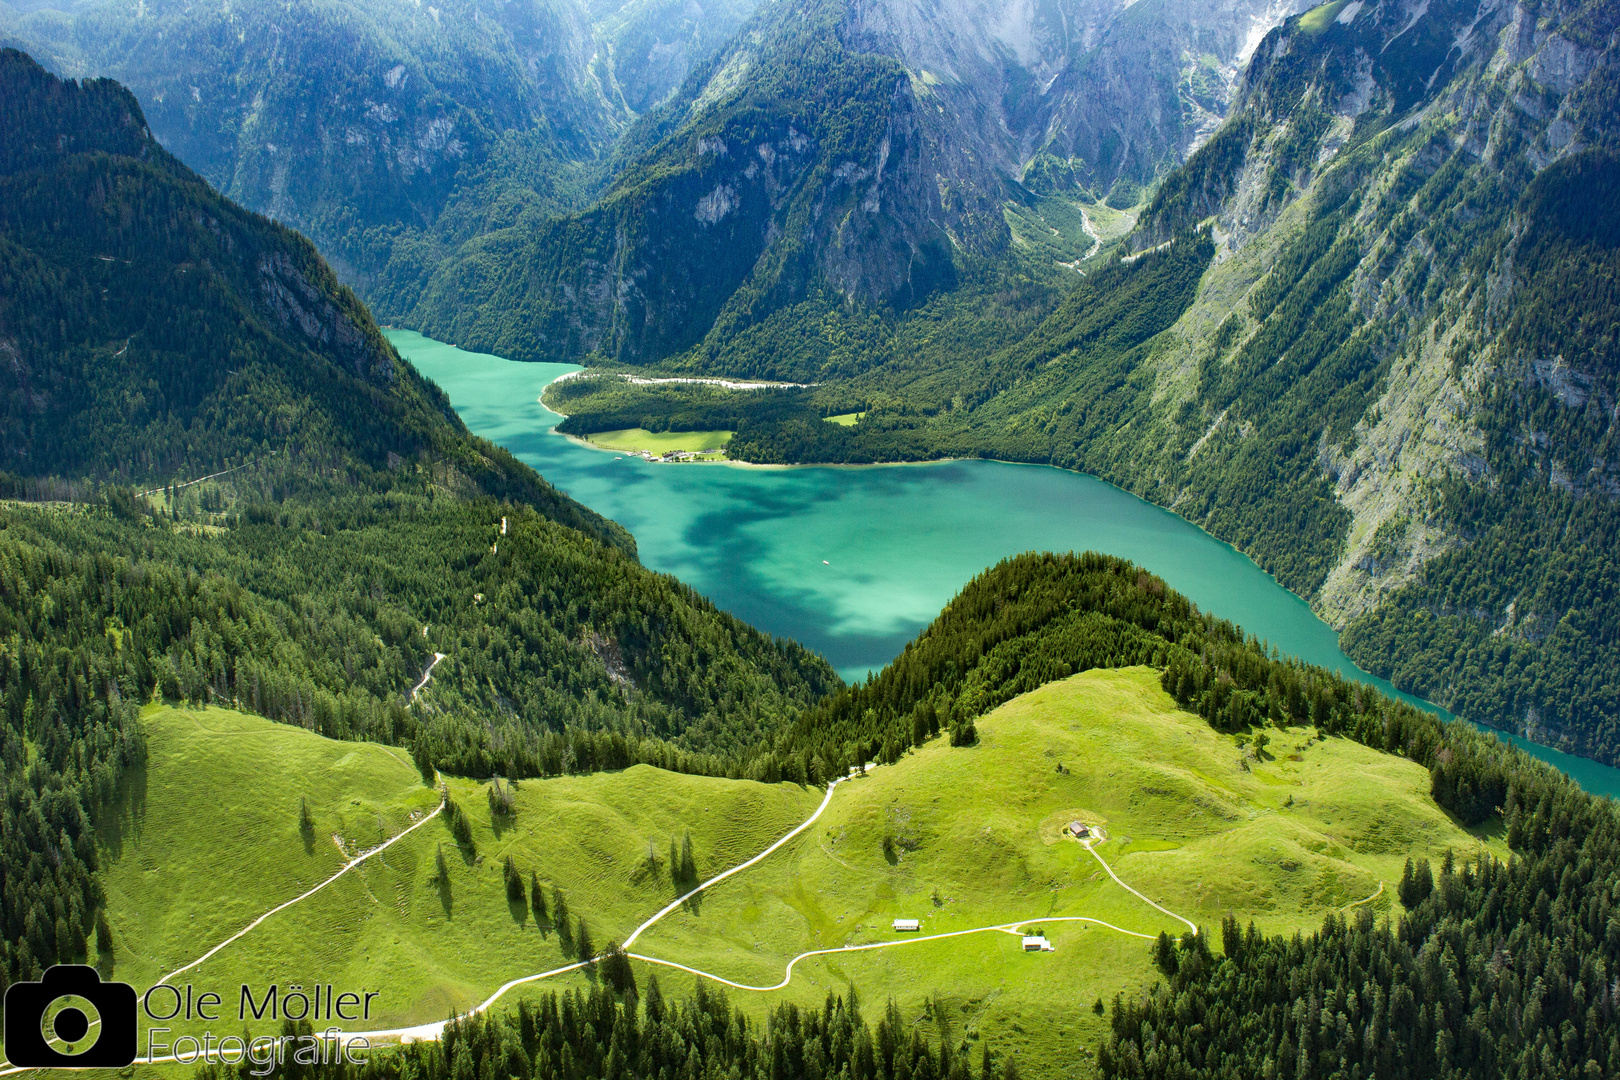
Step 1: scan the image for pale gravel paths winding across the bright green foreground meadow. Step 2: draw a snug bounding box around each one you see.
[0,767,1199,1077]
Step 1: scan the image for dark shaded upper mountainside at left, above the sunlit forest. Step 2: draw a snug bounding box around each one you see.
[0,50,633,551]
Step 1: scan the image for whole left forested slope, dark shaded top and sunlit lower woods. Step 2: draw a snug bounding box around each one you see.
[0,50,839,978]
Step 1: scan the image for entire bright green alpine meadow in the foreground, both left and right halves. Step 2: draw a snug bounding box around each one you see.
[82,669,1483,1075]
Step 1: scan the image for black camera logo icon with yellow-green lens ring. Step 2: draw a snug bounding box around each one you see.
[5,963,136,1069]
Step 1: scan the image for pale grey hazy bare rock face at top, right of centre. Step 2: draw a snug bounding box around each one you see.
[851,0,1309,194]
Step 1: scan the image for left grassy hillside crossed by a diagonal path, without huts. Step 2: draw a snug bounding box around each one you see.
[102,708,820,1033]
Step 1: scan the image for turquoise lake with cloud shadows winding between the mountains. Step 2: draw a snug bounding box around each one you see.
[387,330,1620,797]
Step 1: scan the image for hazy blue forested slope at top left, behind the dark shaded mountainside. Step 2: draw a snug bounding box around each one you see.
[0,0,753,321]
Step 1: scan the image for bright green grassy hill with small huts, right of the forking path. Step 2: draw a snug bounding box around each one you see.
[635,669,1507,1065]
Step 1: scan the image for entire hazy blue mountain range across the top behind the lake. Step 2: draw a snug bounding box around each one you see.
[0,0,1298,346]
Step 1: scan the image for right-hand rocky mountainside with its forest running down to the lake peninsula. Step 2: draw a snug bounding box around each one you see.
[565,0,1620,761]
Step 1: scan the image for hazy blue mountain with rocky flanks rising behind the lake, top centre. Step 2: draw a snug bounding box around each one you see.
[398,0,1290,365]
